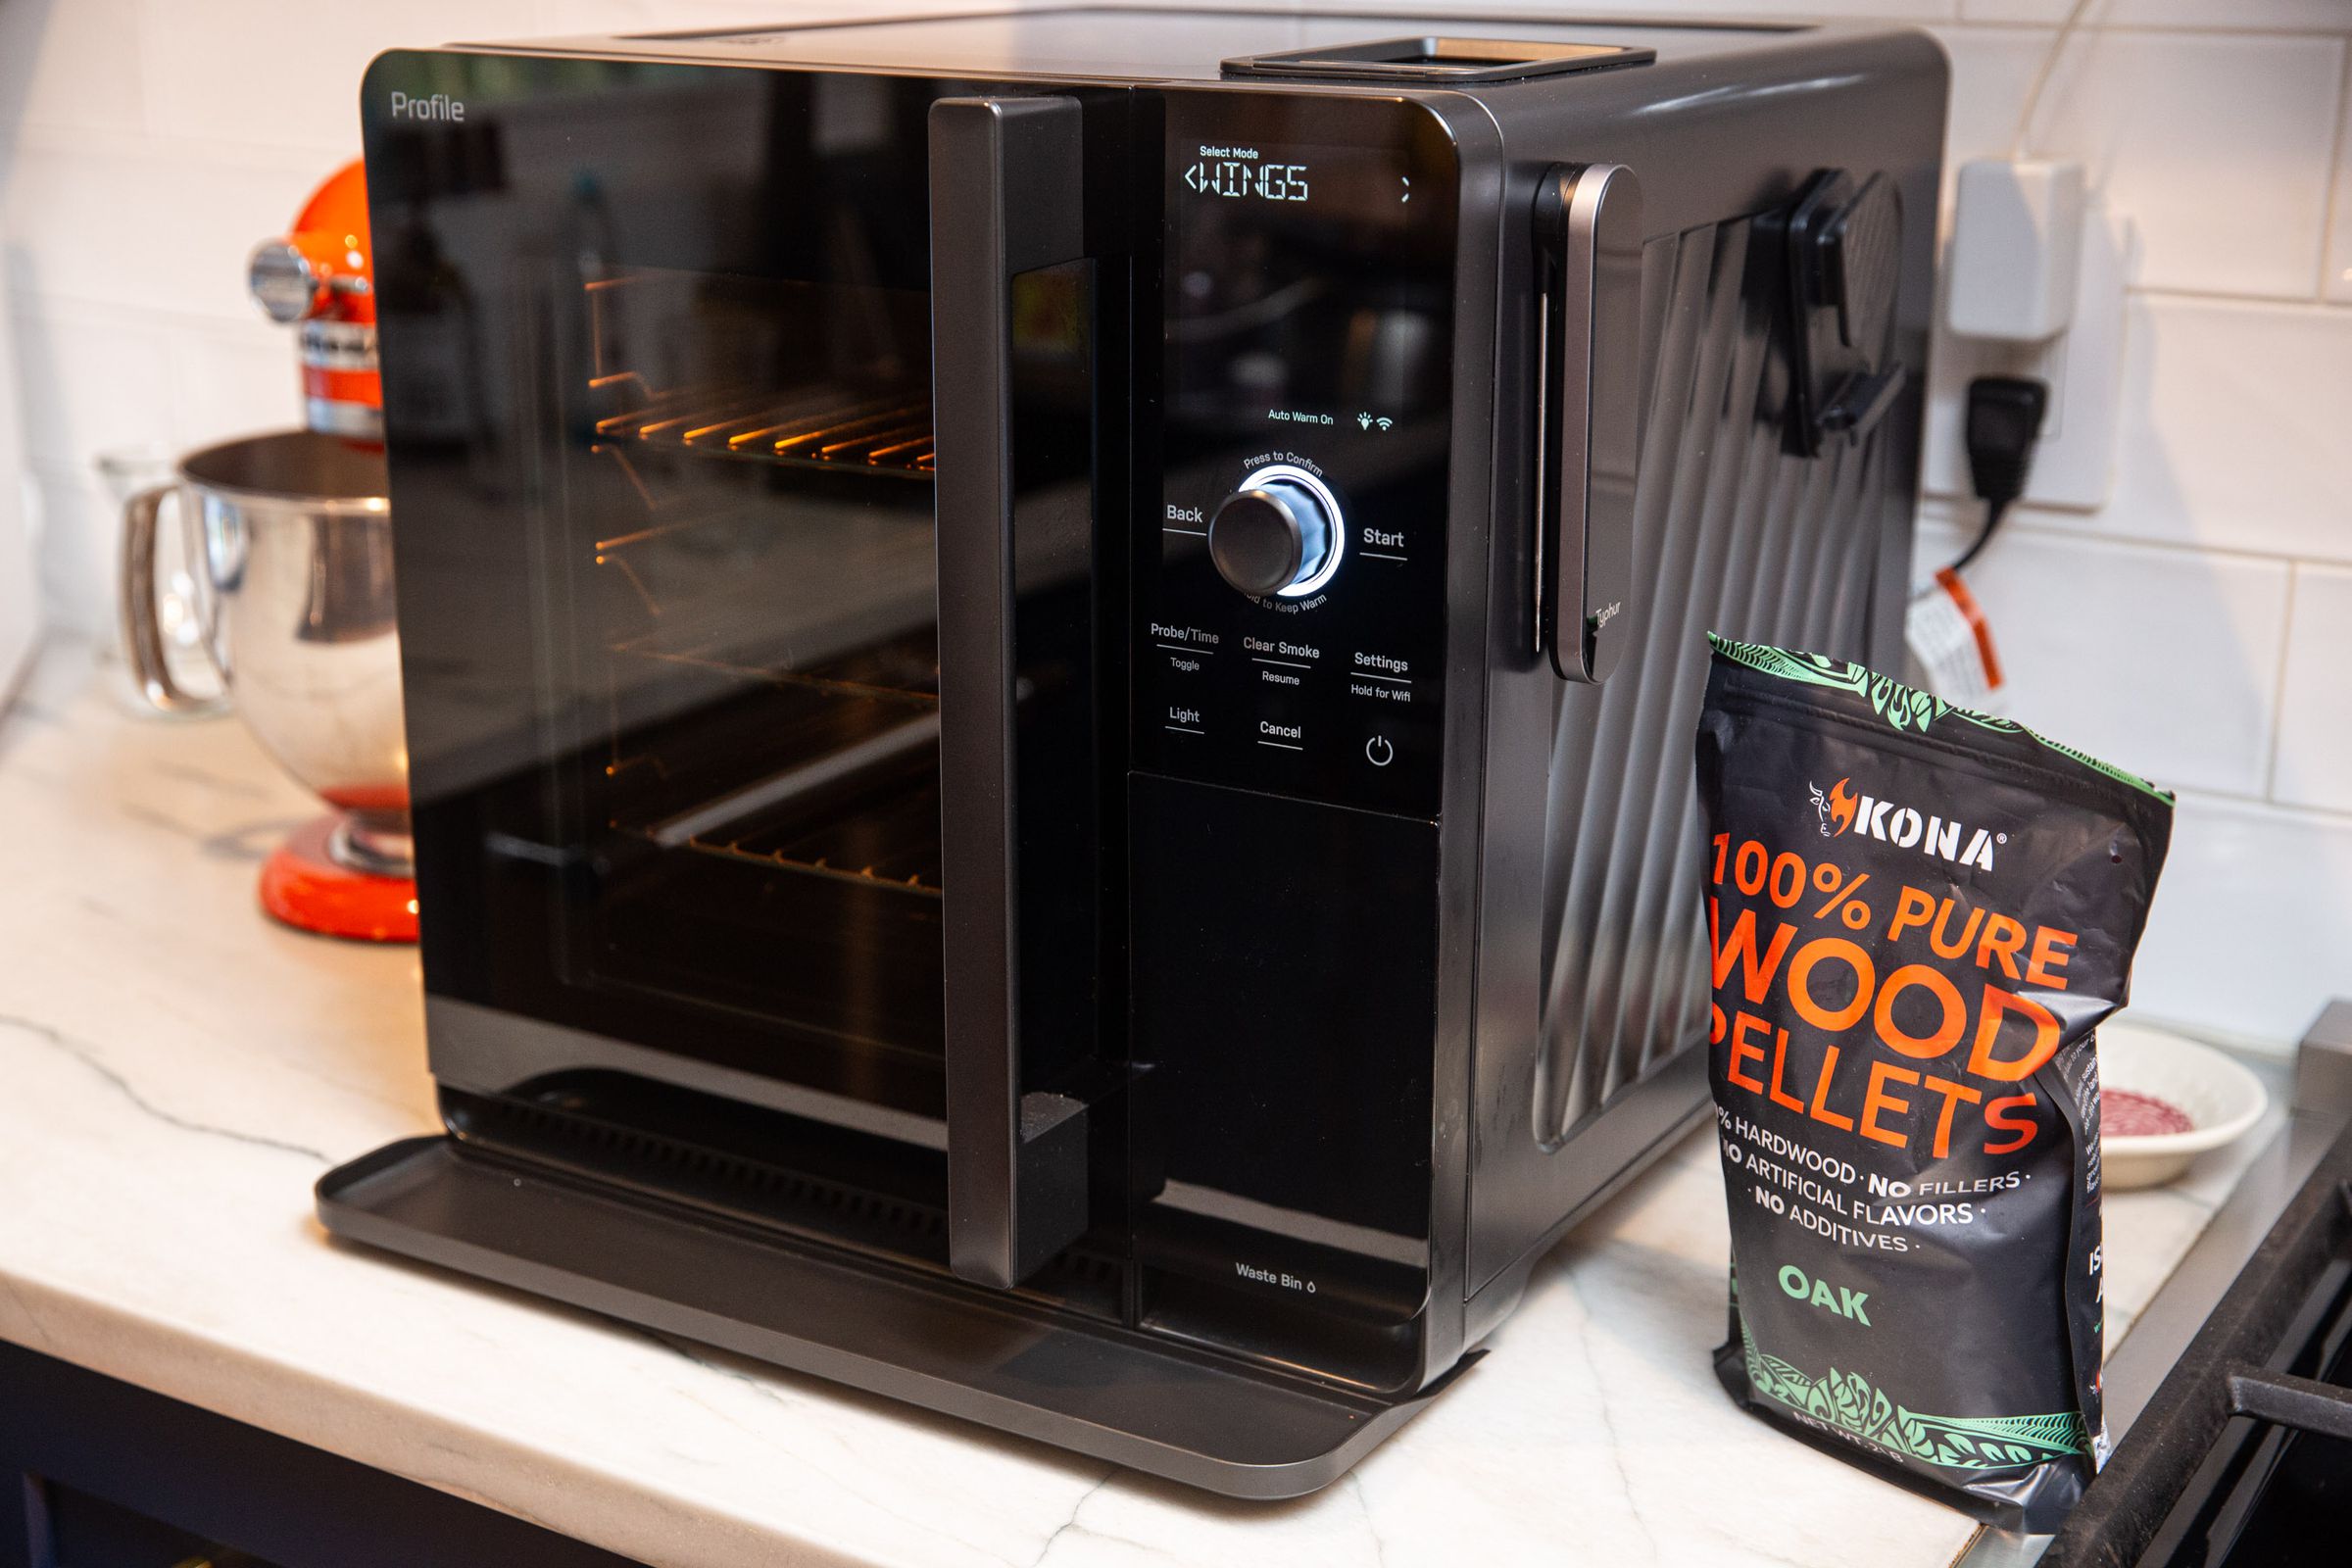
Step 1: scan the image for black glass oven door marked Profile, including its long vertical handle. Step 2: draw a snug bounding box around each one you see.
[365,54,1127,1286]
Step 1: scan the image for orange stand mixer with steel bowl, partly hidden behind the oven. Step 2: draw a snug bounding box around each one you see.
[122,163,416,943]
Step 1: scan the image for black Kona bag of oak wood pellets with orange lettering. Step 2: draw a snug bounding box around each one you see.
[1698,639,2174,1531]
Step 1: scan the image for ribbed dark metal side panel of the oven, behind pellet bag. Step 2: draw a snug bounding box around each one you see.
[1531,220,1886,1145]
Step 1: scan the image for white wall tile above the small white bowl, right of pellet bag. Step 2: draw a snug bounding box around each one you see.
[2131,795,2352,1042]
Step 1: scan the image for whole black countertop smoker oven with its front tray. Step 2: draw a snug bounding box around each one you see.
[319,10,1945,1497]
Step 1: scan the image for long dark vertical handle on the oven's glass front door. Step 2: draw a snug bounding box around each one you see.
[929,96,1087,1289]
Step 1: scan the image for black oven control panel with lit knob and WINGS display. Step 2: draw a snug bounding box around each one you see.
[1131,94,1453,818]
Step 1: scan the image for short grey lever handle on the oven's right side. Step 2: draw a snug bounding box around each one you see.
[1536,165,1642,684]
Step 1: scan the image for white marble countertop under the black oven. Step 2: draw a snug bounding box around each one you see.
[0,647,2285,1568]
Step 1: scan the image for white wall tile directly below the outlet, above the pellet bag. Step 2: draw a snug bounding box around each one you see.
[1919,508,2288,797]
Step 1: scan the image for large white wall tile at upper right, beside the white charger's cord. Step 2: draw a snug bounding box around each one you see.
[2025,33,2345,299]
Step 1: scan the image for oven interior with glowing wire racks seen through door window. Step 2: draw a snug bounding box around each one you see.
[553,268,941,1054]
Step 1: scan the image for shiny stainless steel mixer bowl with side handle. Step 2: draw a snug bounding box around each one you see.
[122,430,410,877]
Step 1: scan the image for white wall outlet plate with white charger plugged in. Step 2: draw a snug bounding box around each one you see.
[1922,205,2140,513]
